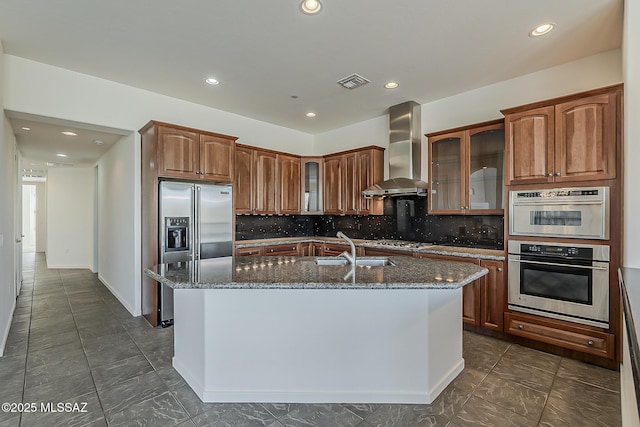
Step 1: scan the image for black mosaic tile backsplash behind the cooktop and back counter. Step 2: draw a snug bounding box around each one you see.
[236,196,504,249]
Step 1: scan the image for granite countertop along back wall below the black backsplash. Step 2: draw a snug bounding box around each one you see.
[235,236,505,261]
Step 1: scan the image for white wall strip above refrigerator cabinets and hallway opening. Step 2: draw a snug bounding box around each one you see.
[4,55,313,154]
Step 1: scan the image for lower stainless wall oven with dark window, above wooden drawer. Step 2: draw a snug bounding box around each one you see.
[508,240,609,328]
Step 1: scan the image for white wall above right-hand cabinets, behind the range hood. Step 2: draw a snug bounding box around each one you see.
[314,49,622,181]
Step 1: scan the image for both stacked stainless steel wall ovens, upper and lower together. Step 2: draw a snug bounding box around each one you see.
[508,187,610,328]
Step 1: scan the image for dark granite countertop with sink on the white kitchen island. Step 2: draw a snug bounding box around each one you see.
[144,256,488,289]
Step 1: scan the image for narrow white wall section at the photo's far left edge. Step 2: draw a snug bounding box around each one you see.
[0,43,16,356]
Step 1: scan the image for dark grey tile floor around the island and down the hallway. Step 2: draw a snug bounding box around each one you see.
[0,254,621,427]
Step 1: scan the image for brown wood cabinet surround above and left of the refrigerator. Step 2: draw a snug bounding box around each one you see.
[139,121,237,326]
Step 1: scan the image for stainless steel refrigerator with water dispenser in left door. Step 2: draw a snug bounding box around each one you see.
[158,181,233,327]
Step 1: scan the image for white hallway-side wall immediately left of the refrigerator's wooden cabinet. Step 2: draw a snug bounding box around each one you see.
[98,134,141,316]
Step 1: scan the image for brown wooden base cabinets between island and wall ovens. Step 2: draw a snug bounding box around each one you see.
[415,253,506,332]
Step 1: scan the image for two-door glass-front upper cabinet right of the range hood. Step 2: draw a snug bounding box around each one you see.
[426,120,504,215]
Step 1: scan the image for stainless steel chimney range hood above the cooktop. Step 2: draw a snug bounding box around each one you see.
[362,101,427,197]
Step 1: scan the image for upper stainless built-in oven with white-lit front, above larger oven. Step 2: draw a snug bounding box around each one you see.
[509,187,609,240]
